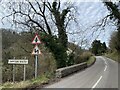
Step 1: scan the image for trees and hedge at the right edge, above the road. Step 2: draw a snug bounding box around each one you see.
[104,2,120,62]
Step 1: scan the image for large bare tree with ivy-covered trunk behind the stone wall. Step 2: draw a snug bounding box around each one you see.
[2,0,77,67]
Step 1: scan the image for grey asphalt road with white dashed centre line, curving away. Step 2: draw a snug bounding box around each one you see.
[45,56,118,89]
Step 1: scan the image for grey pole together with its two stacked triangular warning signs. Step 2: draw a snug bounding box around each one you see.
[32,34,41,78]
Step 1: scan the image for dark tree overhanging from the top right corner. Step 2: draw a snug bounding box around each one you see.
[104,2,120,52]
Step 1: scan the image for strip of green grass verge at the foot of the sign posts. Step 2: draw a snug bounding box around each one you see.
[0,75,49,90]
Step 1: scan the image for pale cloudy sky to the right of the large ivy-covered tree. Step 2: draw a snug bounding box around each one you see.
[67,2,115,47]
